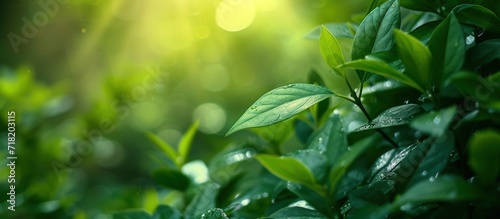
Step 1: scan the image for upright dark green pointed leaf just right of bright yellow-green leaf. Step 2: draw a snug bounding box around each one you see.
[429,13,465,85]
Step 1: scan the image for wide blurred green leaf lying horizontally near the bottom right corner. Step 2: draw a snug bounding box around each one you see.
[395,175,485,206]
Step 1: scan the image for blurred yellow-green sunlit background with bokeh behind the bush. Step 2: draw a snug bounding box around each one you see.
[0,0,369,218]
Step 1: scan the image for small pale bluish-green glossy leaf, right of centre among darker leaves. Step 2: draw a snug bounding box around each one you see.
[410,106,457,137]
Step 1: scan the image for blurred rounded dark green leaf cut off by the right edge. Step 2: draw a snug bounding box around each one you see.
[468,130,500,184]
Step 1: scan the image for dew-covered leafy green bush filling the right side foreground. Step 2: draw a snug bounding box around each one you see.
[115,0,500,218]
